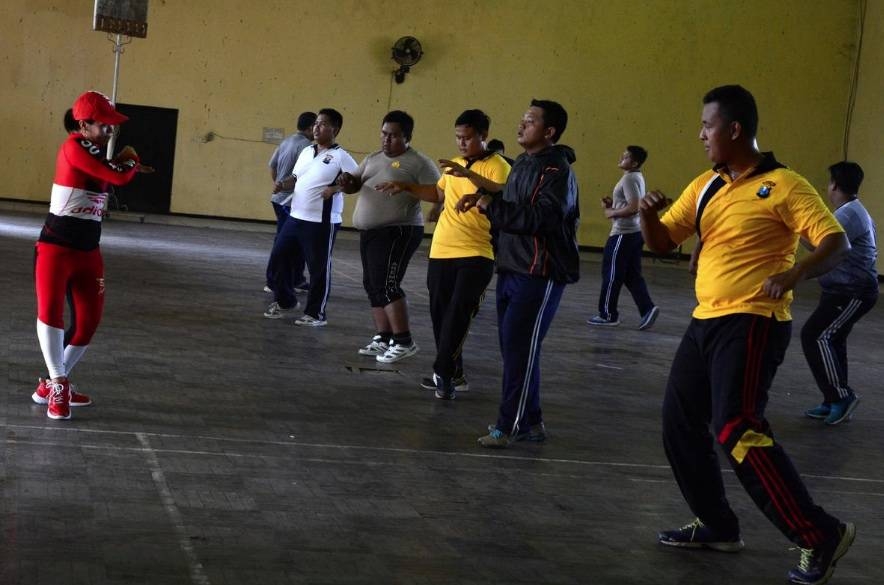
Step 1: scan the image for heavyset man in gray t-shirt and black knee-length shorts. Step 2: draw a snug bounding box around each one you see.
[339,110,440,363]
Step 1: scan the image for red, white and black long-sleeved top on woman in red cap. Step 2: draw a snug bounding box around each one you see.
[40,133,138,250]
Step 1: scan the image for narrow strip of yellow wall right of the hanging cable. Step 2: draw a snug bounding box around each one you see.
[847,0,884,230]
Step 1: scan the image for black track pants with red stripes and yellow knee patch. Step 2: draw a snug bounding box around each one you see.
[663,314,839,548]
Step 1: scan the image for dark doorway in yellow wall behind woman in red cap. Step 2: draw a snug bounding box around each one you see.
[109,103,178,213]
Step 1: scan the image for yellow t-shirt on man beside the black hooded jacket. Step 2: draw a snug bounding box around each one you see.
[430,154,510,260]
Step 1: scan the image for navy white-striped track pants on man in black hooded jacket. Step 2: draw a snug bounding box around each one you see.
[497,272,565,434]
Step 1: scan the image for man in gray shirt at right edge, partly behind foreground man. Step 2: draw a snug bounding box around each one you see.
[801,161,878,425]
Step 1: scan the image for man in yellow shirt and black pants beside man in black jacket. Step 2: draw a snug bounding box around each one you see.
[376,110,510,400]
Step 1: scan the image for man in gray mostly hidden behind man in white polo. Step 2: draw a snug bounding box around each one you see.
[264,112,316,292]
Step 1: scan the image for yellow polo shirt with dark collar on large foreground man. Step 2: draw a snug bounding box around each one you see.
[661,168,844,321]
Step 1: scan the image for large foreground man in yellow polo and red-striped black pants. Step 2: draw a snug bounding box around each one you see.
[639,85,856,585]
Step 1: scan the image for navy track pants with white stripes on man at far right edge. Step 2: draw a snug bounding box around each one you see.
[801,292,878,403]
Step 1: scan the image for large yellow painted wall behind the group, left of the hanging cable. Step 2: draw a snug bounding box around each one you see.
[0,0,868,246]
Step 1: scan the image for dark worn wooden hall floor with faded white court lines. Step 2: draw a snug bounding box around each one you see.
[0,211,884,585]
